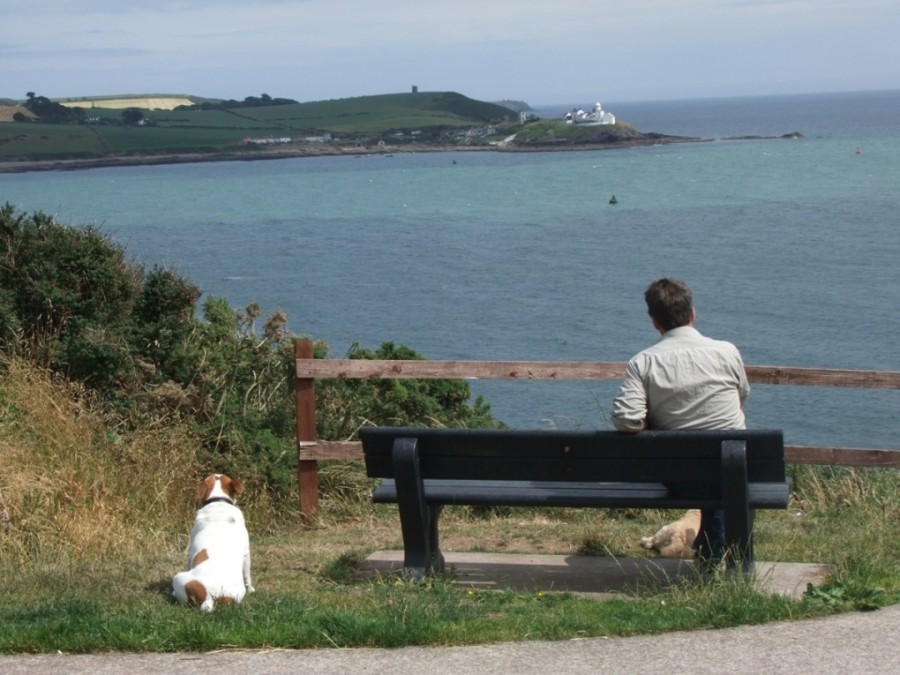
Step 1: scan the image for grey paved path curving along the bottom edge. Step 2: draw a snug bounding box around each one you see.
[0,605,900,675]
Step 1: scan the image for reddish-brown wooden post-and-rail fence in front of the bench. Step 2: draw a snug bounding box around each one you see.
[294,340,900,518]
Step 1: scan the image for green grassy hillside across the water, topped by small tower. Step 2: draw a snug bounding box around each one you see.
[0,92,516,161]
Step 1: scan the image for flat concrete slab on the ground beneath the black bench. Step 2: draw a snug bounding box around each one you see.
[359,551,829,598]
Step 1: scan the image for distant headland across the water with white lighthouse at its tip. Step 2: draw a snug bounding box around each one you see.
[0,88,800,173]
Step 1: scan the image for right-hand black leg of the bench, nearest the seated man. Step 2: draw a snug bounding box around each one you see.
[722,441,754,577]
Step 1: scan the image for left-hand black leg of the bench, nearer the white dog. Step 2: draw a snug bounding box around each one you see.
[392,438,444,578]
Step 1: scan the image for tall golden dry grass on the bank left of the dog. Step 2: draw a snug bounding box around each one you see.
[0,359,200,564]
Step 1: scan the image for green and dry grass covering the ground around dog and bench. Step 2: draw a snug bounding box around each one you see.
[0,362,900,653]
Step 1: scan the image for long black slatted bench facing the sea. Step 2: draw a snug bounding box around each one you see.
[360,427,790,577]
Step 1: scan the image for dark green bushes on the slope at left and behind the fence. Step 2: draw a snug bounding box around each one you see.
[0,204,496,508]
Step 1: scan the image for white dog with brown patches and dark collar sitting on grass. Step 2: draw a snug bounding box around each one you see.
[172,473,254,612]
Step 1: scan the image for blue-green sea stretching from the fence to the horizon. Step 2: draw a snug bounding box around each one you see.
[0,91,900,449]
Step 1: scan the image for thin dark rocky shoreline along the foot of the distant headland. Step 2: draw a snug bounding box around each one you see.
[0,135,711,174]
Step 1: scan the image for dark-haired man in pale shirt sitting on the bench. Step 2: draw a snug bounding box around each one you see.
[613,279,750,570]
